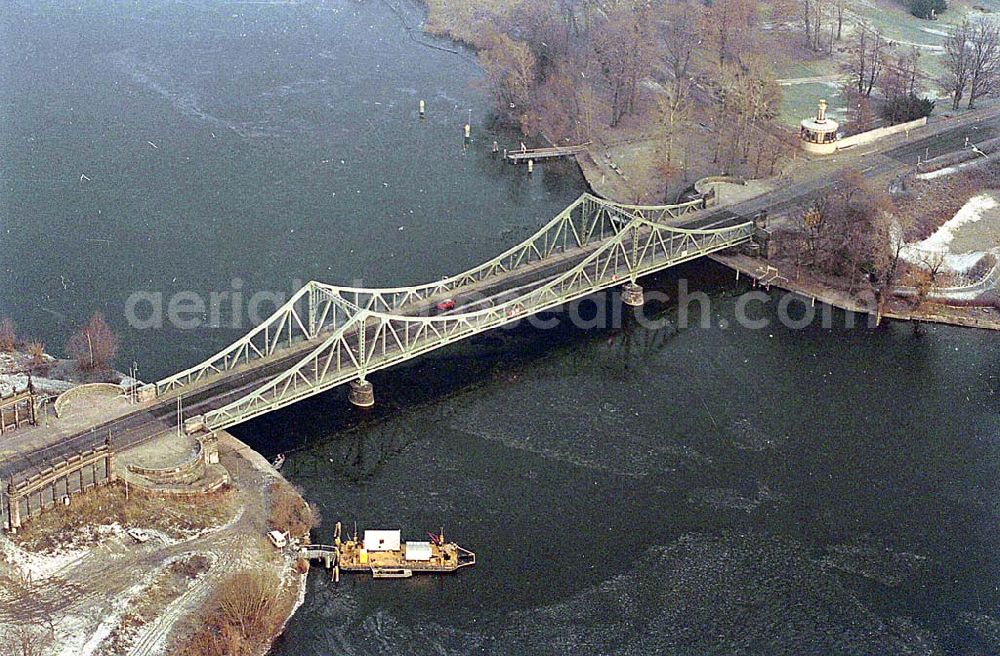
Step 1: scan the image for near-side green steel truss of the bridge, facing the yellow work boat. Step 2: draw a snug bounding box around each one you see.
[205,217,754,430]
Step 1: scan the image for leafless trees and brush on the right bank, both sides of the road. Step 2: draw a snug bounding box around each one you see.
[422,0,1000,329]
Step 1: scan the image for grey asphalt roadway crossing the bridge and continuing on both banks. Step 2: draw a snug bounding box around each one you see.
[0,104,1000,482]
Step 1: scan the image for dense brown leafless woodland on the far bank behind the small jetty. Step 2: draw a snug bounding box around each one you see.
[476,0,792,182]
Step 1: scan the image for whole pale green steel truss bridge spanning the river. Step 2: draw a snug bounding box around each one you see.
[150,194,755,432]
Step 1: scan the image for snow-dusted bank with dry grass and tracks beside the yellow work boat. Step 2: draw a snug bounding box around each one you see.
[0,433,307,656]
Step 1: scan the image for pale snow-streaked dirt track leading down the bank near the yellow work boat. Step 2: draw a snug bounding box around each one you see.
[0,436,299,656]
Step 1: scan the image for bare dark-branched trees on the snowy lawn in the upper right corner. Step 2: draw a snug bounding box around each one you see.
[942,18,1000,109]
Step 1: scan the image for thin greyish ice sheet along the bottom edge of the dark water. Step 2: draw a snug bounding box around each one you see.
[294,533,944,656]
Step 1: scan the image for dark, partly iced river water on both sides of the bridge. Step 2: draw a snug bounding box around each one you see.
[0,0,1000,656]
